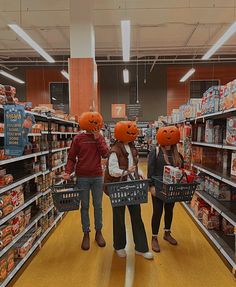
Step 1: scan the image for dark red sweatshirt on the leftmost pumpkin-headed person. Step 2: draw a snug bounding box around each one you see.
[66,133,109,177]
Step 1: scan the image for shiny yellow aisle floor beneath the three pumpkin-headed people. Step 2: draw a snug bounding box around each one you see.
[11,162,235,287]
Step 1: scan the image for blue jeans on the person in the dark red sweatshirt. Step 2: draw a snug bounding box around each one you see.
[77,176,103,232]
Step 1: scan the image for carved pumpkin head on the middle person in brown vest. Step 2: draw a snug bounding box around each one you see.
[114,121,138,143]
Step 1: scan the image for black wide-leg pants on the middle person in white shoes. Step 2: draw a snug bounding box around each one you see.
[113,205,148,252]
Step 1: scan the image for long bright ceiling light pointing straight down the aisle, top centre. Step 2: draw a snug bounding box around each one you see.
[121,20,130,62]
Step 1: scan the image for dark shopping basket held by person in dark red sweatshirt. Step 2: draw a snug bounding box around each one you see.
[52,183,80,212]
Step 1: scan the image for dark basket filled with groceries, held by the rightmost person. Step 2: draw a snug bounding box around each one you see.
[153,176,198,203]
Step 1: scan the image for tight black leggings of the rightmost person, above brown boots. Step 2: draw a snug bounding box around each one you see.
[152,196,175,235]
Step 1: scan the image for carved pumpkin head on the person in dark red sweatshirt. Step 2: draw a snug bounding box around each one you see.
[79,112,103,132]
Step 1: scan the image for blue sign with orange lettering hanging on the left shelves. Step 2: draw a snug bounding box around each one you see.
[4,105,25,156]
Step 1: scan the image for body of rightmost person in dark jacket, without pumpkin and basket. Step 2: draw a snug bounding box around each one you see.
[148,127,183,252]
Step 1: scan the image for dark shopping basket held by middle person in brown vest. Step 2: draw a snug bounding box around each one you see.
[106,174,149,207]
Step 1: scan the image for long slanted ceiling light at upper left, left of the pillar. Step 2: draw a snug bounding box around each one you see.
[8,24,55,63]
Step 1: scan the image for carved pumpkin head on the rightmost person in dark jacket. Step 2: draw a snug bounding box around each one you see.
[156,126,180,146]
